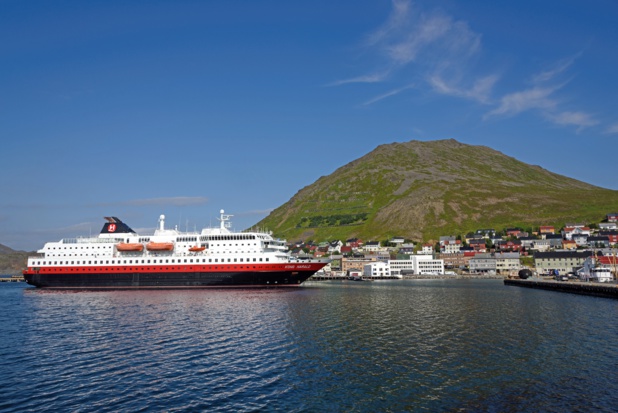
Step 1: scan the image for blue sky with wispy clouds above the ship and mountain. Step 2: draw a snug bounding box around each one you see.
[0,0,618,250]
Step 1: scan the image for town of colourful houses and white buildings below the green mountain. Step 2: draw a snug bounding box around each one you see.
[289,213,618,282]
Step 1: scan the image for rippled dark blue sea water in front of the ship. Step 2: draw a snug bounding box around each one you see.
[0,280,618,412]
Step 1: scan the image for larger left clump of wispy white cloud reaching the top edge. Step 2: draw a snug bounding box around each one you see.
[328,0,490,101]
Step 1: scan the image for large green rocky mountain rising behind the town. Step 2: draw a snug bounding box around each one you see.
[257,139,618,241]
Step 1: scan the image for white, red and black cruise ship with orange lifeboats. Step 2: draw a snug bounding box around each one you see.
[23,210,329,289]
